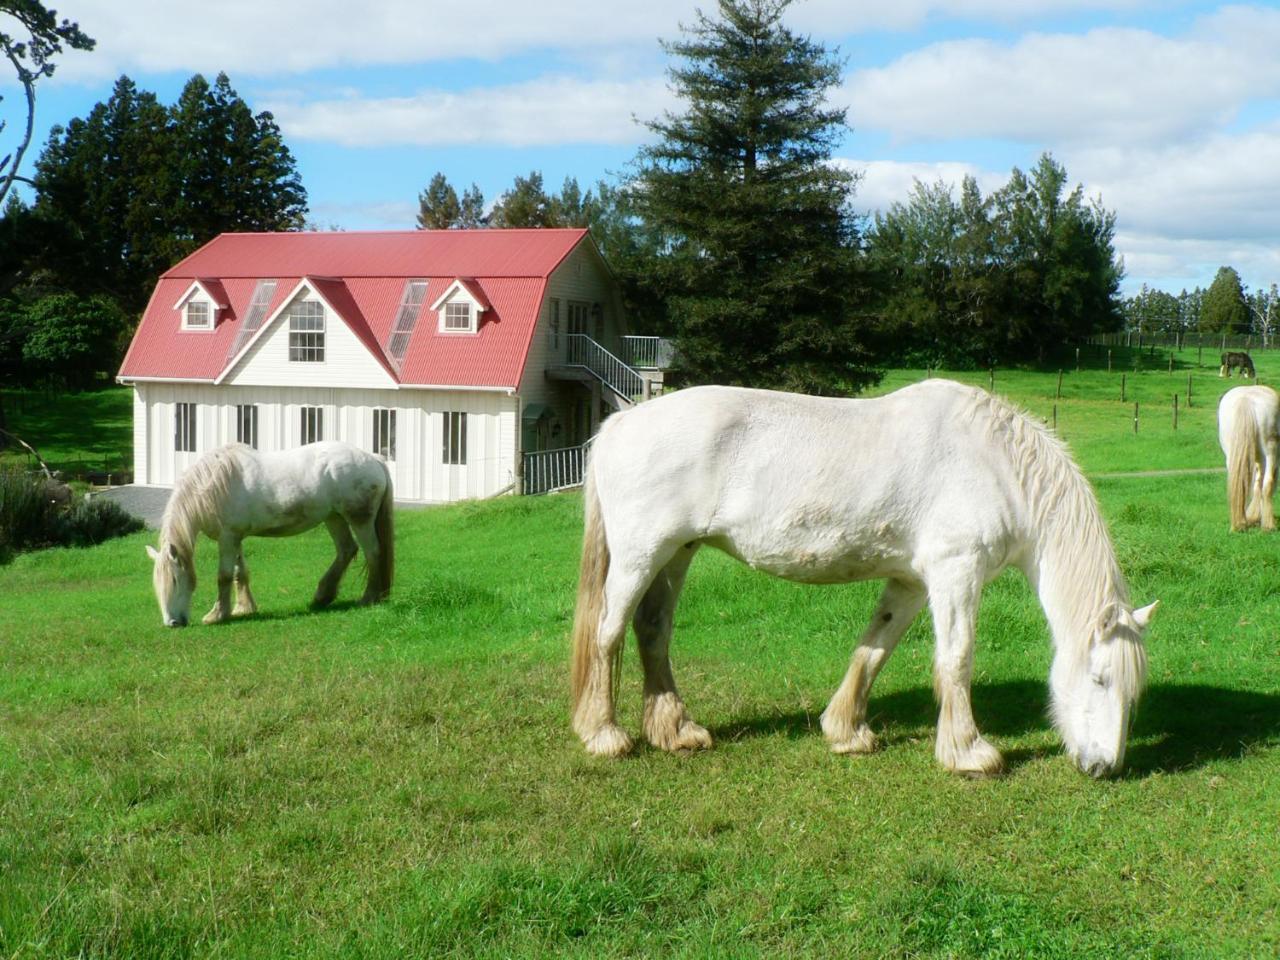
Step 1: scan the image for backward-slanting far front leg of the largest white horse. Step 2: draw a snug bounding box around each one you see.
[822,580,927,754]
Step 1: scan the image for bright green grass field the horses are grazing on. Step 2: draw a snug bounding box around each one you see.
[0,353,1280,959]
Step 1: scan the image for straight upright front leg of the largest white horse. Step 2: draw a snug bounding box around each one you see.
[928,562,1004,776]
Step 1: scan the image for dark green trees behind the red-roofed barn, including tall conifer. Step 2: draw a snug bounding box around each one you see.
[0,0,1141,393]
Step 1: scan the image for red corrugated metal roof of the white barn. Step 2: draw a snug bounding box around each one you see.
[119,229,586,389]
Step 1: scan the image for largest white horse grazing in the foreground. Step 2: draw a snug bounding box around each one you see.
[572,380,1156,776]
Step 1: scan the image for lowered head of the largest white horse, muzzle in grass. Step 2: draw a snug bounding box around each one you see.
[1050,600,1160,777]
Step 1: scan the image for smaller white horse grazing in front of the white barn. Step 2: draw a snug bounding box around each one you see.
[147,442,396,627]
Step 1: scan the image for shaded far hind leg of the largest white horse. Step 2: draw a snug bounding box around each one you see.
[631,544,712,750]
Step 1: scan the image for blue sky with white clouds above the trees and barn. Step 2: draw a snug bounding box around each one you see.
[0,0,1280,292]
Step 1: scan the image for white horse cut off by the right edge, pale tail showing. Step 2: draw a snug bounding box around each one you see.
[1217,387,1280,530]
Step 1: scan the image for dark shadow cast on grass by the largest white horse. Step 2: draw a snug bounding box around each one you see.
[710,680,1280,777]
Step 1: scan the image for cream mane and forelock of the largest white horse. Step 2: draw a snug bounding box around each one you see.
[970,389,1146,699]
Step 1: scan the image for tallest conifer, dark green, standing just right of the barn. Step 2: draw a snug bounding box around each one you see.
[628,0,876,392]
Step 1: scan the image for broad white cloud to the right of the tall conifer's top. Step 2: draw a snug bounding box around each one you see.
[845,8,1280,148]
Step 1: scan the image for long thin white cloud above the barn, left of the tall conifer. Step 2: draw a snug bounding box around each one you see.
[266,77,671,147]
